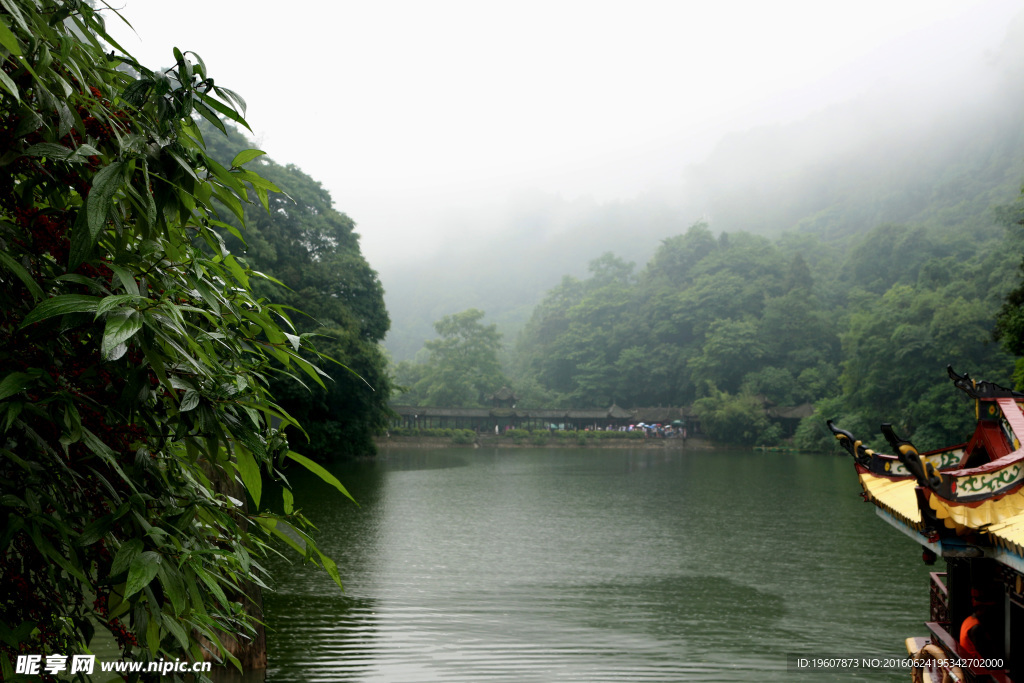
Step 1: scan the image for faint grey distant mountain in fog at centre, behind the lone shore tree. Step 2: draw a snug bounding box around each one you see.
[381,193,689,360]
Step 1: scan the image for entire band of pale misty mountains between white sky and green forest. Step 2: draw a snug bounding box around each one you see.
[380,10,1024,359]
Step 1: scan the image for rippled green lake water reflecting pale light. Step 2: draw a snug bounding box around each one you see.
[234,449,941,683]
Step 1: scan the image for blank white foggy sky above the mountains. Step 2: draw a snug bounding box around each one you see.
[109,0,1024,272]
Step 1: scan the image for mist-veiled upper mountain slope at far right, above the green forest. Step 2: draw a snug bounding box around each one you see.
[686,19,1024,240]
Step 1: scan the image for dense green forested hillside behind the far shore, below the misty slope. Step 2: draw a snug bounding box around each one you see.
[514,215,1024,447]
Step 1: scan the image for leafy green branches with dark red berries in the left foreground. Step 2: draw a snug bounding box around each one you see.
[0,0,344,680]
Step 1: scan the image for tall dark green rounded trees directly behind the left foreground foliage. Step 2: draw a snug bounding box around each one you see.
[203,122,391,459]
